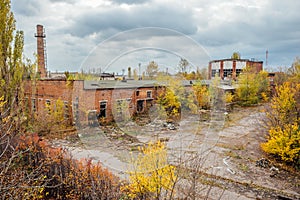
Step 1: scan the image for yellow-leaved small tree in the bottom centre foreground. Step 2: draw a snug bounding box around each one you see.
[123,141,177,199]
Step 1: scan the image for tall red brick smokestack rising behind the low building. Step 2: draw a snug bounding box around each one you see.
[34,24,47,78]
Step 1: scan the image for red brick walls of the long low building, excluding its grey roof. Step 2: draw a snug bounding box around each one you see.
[25,79,162,125]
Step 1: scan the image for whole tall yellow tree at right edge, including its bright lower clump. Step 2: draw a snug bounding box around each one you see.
[261,82,300,167]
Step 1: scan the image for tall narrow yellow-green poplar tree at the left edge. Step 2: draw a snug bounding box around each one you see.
[0,0,25,112]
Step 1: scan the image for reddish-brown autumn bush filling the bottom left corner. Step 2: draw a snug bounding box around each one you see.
[0,134,124,199]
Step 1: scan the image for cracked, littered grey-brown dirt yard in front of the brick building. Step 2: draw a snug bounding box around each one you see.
[53,106,300,200]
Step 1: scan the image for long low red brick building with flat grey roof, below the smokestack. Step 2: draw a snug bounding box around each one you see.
[25,78,161,124]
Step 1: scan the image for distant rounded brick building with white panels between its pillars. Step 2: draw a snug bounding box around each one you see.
[208,59,263,80]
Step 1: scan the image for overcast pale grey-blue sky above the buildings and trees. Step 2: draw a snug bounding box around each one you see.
[11,0,300,74]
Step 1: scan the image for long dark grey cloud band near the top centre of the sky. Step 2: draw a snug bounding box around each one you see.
[66,4,197,37]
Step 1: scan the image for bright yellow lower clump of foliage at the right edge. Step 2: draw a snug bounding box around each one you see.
[261,124,300,162]
